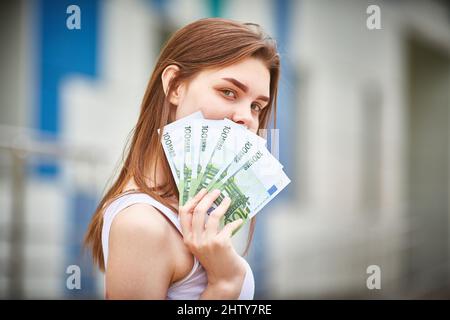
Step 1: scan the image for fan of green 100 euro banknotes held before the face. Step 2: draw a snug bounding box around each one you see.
[161,111,290,234]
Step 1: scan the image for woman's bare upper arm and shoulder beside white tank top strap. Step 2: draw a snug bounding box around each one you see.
[105,204,175,299]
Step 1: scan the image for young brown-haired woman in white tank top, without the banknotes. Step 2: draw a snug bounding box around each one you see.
[85,18,280,299]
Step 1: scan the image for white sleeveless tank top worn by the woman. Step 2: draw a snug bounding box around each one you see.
[102,193,255,300]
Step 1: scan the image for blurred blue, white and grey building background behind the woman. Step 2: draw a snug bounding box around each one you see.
[0,0,450,299]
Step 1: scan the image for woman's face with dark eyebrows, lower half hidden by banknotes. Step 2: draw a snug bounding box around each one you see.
[163,58,270,133]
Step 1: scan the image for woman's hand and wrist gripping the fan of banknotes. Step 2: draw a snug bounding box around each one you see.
[179,189,246,298]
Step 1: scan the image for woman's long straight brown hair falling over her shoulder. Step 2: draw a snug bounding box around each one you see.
[84,18,280,271]
